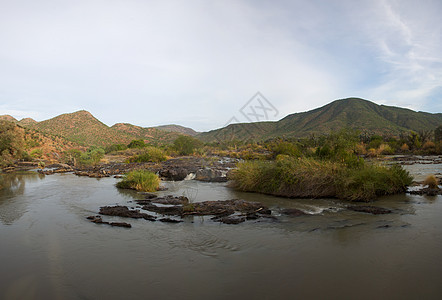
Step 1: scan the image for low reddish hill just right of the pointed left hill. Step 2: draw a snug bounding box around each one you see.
[111,123,180,144]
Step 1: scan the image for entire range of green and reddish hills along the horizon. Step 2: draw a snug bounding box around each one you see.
[6,98,442,147]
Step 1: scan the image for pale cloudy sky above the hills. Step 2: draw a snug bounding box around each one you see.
[0,0,442,131]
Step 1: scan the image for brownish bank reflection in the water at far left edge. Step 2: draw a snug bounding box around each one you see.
[0,172,45,225]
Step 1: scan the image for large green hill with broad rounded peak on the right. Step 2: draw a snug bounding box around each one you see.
[197,98,442,142]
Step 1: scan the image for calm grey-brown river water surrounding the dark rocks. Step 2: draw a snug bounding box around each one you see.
[0,165,442,299]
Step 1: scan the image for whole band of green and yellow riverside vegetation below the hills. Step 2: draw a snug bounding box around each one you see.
[0,121,442,201]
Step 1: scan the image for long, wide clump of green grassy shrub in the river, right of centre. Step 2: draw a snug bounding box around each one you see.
[230,155,412,201]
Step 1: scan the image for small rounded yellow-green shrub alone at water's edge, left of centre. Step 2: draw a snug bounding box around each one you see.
[117,170,160,192]
